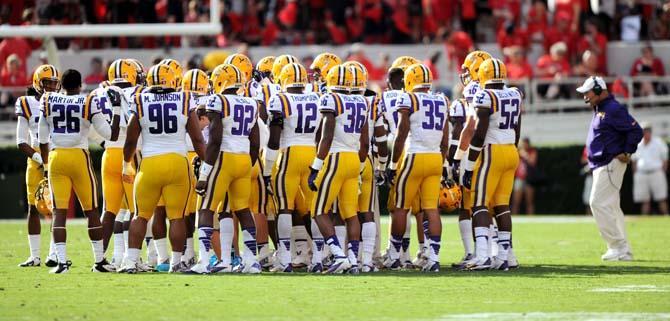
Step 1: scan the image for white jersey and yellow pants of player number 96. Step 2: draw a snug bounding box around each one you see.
[131,90,194,220]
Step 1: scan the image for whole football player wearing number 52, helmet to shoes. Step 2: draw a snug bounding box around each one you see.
[462,59,523,271]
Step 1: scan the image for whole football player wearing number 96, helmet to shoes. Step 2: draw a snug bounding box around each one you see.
[119,64,205,273]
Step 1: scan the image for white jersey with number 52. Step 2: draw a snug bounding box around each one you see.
[473,87,523,145]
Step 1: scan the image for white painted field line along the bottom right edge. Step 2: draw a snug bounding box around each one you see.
[436,312,670,321]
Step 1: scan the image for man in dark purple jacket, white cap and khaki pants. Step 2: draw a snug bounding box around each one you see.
[577,77,642,261]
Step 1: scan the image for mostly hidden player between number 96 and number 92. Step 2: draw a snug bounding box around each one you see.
[181,69,210,268]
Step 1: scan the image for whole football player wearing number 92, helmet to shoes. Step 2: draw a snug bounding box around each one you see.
[191,64,261,274]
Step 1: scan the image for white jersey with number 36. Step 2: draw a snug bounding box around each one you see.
[319,93,368,153]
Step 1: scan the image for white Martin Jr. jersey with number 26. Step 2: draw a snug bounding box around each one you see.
[40,92,103,149]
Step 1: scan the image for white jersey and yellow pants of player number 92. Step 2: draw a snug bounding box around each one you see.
[199,94,261,213]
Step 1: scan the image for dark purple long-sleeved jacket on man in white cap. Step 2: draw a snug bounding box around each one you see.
[586,95,642,169]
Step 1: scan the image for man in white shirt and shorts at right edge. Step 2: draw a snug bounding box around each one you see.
[633,124,668,214]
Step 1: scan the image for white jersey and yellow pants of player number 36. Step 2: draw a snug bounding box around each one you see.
[311,93,368,219]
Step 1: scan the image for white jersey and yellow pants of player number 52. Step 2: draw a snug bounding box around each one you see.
[470,87,523,207]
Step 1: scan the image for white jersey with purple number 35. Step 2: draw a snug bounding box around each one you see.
[398,92,448,153]
